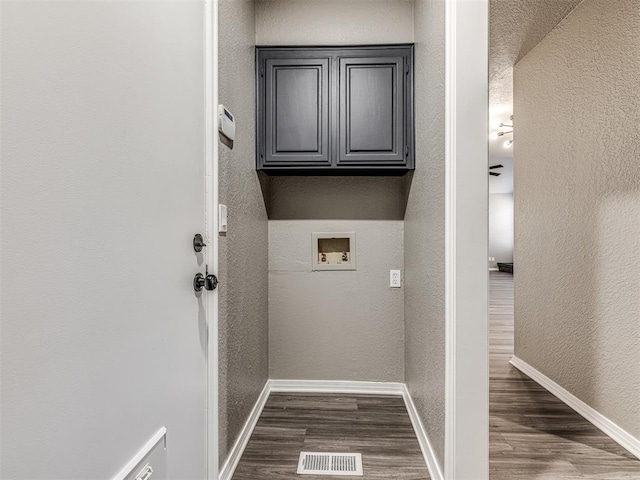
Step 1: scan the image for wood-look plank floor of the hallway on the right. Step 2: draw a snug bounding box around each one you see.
[489,272,640,480]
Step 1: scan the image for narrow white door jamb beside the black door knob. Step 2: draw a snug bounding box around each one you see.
[203,0,219,480]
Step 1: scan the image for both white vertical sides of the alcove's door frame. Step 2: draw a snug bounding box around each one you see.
[204,0,489,480]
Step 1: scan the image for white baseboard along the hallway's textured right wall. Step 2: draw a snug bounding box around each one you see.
[510,356,640,458]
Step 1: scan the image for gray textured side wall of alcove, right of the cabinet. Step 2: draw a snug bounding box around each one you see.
[404,0,445,465]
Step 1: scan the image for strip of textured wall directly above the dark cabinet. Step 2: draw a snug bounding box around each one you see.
[256,0,413,45]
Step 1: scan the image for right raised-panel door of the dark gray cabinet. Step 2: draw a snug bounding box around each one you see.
[337,56,406,165]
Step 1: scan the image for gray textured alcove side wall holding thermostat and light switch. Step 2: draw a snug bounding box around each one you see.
[219,0,268,463]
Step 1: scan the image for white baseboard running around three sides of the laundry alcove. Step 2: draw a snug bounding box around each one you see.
[219,380,444,480]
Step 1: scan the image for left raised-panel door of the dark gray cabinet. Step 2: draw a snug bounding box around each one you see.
[263,58,331,166]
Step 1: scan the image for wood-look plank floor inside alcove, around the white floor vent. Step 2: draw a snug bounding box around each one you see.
[233,393,429,480]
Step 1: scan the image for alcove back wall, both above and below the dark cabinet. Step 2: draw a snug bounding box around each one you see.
[256,0,413,381]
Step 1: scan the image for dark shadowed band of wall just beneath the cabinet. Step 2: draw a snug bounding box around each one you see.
[263,176,407,220]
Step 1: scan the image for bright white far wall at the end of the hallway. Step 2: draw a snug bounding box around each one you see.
[489,193,513,267]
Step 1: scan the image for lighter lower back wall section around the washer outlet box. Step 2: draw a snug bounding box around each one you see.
[269,220,404,382]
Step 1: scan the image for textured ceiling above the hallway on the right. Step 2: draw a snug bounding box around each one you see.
[489,0,582,193]
